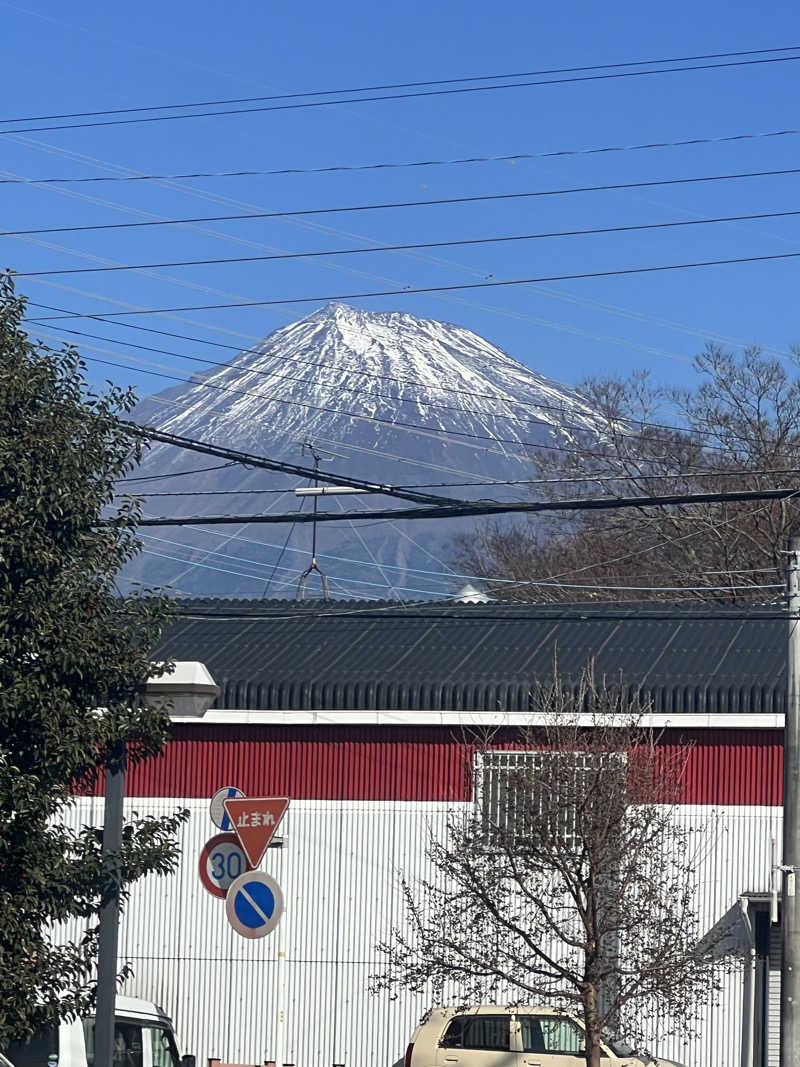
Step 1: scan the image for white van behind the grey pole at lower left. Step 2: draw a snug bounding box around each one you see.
[5,997,194,1067]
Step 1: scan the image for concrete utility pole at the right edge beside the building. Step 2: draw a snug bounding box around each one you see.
[781,537,800,1067]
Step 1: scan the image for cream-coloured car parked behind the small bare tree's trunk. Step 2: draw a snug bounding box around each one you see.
[404,1005,681,1067]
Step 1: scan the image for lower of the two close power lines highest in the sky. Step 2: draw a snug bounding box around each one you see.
[6,55,800,137]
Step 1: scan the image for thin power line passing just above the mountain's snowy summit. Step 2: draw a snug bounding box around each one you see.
[31,247,800,322]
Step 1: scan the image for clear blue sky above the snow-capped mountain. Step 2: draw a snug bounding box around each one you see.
[0,0,800,407]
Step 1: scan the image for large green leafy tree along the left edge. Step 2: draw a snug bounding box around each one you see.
[0,274,183,1048]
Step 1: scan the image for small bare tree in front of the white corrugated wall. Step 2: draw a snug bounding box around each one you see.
[373,669,734,1067]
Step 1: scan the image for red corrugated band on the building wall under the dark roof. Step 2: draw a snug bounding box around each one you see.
[106,724,783,806]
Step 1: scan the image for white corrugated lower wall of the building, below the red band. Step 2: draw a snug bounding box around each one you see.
[61,798,780,1067]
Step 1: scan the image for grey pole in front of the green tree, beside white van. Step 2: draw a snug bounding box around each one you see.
[94,740,125,1067]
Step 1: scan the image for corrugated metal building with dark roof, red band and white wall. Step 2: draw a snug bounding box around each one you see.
[74,601,786,1067]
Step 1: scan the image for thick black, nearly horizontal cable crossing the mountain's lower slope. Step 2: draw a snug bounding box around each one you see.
[131,489,798,526]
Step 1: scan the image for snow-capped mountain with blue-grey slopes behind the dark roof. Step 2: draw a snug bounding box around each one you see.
[125,303,596,599]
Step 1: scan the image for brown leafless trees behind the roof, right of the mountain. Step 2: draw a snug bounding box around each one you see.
[455,346,800,602]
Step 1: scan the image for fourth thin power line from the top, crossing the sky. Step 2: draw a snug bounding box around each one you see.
[6,164,800,237]
